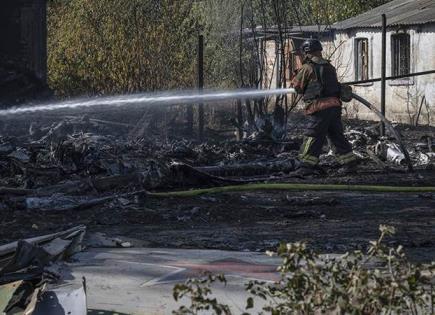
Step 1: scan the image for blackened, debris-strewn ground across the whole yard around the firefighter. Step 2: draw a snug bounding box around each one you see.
[0,108,435,260]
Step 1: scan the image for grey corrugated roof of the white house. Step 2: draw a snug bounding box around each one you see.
[331,0,435,30]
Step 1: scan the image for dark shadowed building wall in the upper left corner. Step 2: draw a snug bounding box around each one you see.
[0,0,47,82]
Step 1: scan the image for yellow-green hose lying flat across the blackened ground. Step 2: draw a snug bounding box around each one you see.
[148,183,435,197]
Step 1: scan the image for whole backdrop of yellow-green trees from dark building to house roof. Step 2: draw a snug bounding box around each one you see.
[48,0,392,95]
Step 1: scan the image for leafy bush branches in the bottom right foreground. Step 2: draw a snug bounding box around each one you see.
[174,225,435,315]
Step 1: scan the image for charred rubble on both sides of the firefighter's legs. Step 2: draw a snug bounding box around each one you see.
[0,115,434,215]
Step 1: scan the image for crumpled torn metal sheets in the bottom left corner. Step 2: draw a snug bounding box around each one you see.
[0,226,87,315]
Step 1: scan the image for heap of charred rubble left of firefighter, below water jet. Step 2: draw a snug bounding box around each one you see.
[0,116,299,210]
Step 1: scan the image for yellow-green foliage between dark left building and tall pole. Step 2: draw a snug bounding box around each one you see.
[48,0,198,95]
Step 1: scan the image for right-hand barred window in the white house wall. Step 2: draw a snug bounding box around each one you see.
[391,34,411,76]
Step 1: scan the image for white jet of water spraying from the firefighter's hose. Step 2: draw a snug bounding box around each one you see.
[0,88,296,116]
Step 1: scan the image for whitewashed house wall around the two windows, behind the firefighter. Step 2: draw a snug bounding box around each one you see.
[332,24,435,125]
